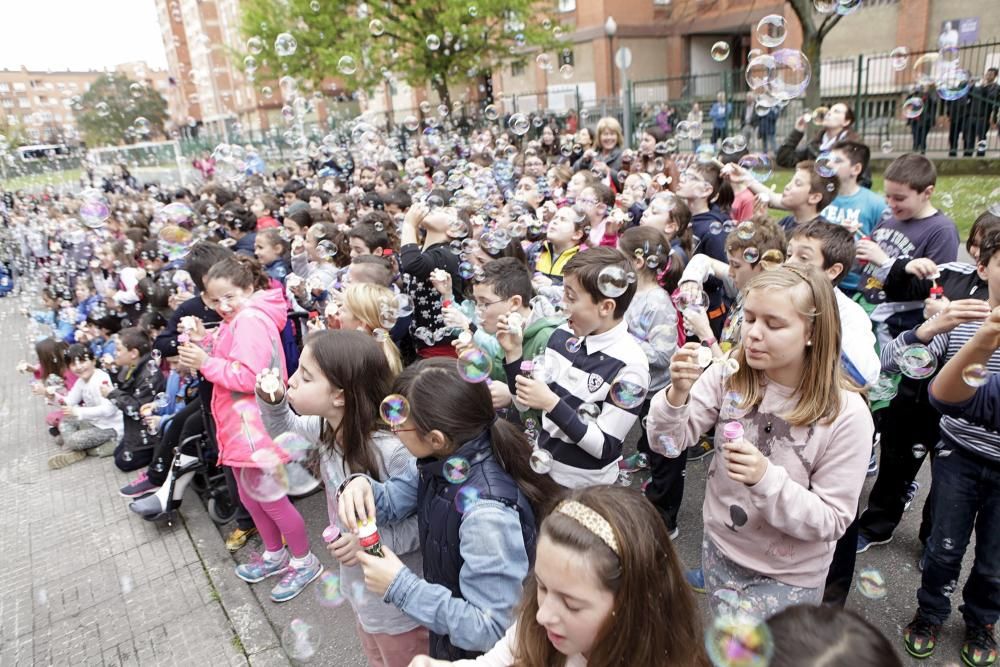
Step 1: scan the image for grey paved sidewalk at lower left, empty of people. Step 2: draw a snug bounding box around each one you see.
[0,298,259,666]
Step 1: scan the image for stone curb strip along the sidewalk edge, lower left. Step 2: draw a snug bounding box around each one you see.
[181,498,291,667]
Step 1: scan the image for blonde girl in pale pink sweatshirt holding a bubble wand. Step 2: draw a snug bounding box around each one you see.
[648,265,873,620]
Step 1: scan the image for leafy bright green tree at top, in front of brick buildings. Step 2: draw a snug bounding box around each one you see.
[239,0,563,107]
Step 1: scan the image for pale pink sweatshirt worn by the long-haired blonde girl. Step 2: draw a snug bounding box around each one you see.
[647,364,874,588]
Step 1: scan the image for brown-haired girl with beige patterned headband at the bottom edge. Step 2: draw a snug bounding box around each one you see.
[410,486,709,667]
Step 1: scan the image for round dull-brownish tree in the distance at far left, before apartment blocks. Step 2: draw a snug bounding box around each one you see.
[73,72,167,146]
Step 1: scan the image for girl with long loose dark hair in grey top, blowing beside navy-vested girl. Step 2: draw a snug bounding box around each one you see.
[257,331,427,667]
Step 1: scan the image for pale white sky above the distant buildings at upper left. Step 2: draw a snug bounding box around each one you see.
[0,0,167,71]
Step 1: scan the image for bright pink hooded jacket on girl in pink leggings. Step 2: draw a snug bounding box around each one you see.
[201,289,288,468]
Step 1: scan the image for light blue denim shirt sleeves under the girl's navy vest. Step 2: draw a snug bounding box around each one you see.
[371,454,530,651]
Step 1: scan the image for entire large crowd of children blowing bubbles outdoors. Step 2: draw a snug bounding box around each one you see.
[0,104,1000,667]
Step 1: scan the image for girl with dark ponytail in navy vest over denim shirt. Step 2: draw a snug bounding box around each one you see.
[339,358,557,660]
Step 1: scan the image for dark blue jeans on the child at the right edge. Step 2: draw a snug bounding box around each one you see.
[917,441,1000,625]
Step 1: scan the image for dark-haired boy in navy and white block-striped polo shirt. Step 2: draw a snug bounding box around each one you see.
[497,247,649,488]
